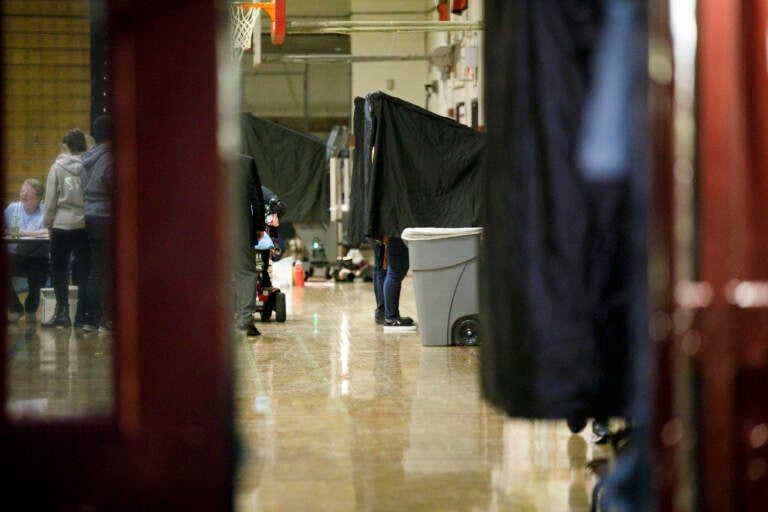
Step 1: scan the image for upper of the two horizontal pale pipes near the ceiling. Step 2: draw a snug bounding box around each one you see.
[285,20,483,34]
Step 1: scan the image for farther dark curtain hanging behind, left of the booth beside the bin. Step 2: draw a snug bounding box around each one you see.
[240,113,330,223]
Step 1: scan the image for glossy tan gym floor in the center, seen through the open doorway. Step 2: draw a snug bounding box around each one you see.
[235,278,612,512]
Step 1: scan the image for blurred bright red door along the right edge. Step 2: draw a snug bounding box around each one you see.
[651,0,768,512]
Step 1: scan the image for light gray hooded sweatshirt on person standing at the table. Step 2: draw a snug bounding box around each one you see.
[43,153,85,229]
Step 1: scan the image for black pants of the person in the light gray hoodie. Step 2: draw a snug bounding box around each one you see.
[51,228,90,318]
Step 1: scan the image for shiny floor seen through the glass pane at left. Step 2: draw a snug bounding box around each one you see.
[6,315,113,420]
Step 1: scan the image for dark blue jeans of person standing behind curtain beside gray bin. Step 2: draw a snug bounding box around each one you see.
[373,238,410,319]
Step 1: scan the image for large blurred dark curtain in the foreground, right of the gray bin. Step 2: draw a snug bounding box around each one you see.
[480,0,640,426]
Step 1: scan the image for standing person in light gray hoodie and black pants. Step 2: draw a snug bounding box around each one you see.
[41,128,90,327]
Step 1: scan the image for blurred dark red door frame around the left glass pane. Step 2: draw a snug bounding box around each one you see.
[0,0,233,511]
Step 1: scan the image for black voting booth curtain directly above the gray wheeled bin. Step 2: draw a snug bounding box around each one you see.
[347,92,485,246]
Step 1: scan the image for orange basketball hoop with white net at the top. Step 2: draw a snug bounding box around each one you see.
[229,0,285,61]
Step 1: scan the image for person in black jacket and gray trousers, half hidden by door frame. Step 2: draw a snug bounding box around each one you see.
[234,155,266,336]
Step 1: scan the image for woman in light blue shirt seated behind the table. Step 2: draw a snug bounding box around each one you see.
[4,178,48,324]
